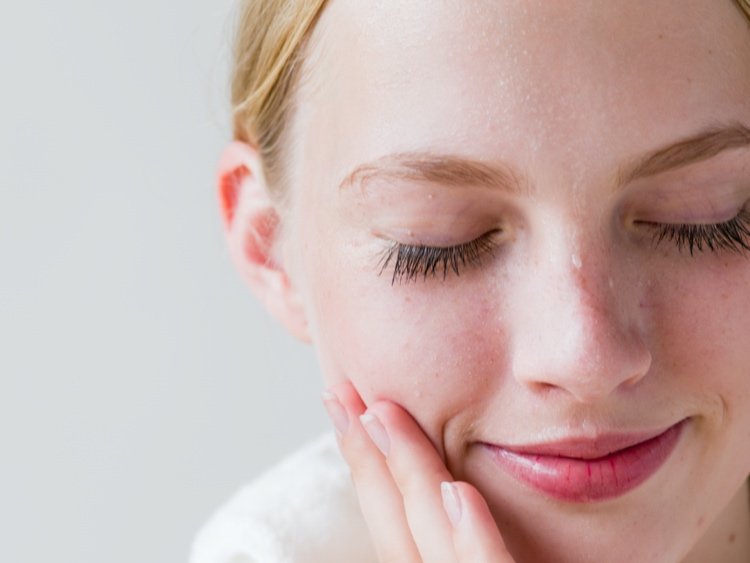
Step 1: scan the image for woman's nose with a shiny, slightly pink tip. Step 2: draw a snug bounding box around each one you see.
[510,236,651,403]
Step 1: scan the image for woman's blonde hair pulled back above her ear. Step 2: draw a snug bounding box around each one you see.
[231,0,750,195]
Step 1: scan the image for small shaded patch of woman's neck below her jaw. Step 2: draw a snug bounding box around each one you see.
[682,480,750,563]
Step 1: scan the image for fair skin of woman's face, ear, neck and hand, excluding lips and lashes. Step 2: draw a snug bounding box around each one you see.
[219,0,750,563]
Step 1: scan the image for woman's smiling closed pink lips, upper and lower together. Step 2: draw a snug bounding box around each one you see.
[482,419,687,502]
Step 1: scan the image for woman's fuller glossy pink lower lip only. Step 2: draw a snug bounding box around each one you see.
[483,421,684,503]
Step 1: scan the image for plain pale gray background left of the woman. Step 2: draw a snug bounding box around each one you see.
[0,0,327,563]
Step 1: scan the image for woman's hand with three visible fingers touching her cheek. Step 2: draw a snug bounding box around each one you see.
[323,382,513,563]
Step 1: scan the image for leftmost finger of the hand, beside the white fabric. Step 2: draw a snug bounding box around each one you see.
[323,383,421,563]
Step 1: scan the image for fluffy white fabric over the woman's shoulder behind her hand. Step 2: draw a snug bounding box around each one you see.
[190,434,377,563]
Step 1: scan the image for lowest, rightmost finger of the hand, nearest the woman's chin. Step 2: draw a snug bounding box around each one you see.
[441,481,513,563]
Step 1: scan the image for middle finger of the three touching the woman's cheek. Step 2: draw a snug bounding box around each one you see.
[362,401,456,563]
